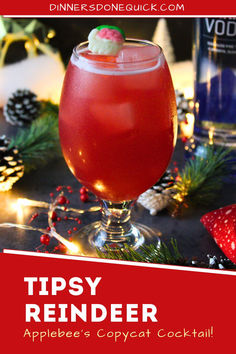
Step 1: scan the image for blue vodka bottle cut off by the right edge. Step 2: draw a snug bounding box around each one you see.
[195,18,236,134]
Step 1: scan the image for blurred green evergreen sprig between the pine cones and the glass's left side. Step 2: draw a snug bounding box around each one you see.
[9,111,60,172]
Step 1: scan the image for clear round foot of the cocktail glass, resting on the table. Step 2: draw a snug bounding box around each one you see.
[73,221,161,257]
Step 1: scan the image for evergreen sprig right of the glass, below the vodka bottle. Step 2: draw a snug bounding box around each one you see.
[174,146,230,209]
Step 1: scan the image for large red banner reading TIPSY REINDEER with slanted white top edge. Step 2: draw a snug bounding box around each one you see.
[0,251,236,353]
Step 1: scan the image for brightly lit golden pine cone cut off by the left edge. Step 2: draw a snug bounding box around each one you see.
[0,135,24,192]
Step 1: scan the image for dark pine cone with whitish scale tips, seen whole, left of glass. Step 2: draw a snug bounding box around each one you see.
[3,90,40,126]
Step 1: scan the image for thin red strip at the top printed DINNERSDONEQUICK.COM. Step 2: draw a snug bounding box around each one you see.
[0,0,236,17]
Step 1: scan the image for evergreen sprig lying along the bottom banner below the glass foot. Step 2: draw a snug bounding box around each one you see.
[96,239,186,265]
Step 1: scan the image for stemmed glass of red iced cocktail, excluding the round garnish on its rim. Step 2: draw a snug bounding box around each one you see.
[59,39,177,254]
